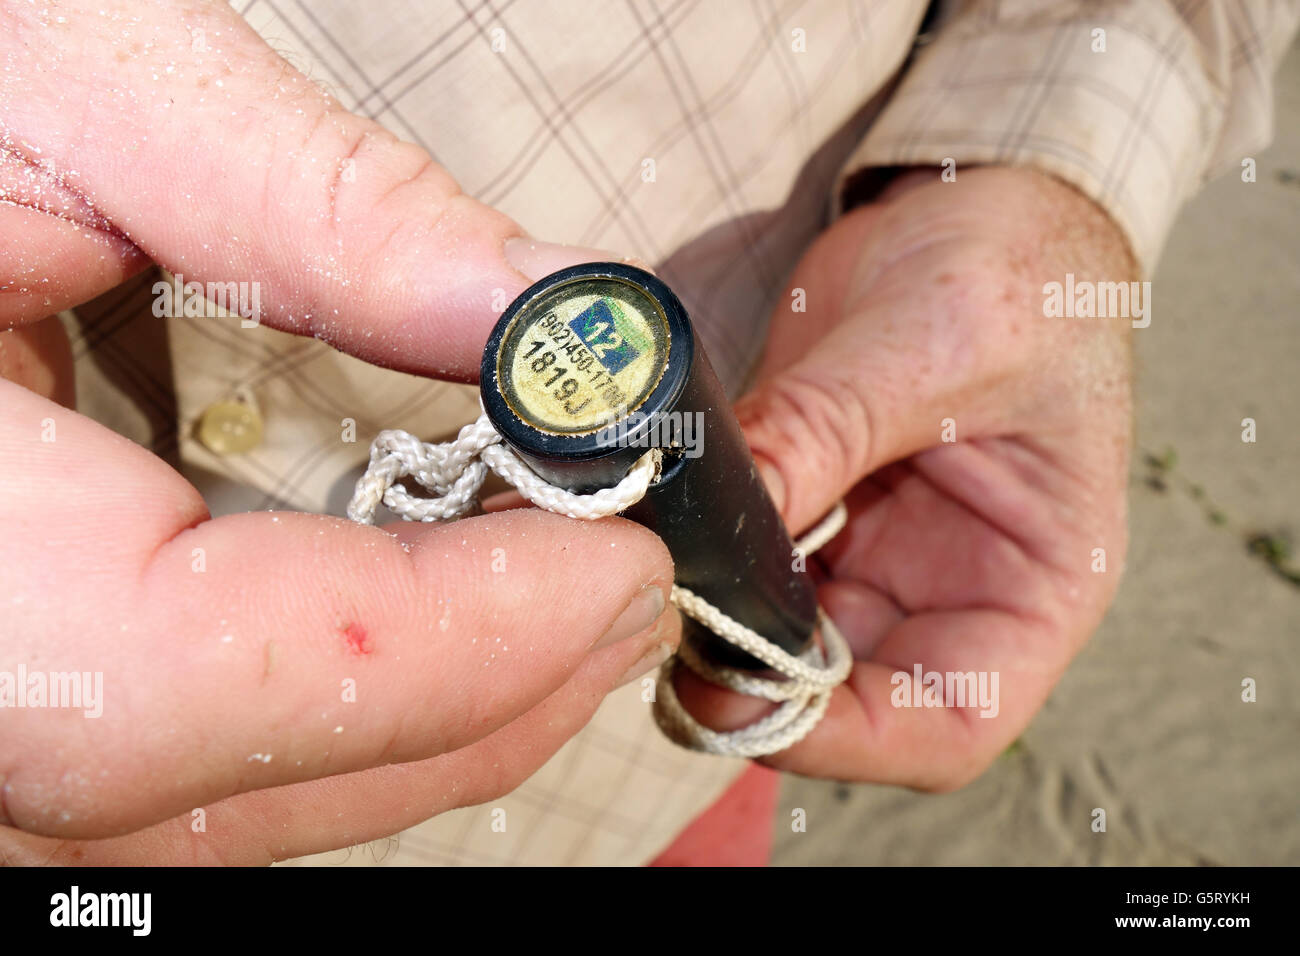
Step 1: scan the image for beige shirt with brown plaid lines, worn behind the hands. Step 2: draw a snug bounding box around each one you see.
[65,0,1300,865]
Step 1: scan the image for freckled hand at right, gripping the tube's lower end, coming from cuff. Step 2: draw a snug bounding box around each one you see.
[681,168,1136,790]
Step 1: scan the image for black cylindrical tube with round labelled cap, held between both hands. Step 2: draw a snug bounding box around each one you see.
[480,263,816,669]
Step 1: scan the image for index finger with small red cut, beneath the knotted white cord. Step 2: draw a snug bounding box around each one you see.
[0,382,676,836]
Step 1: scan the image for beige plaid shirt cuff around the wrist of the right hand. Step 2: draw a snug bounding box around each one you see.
[835,10,1226,274]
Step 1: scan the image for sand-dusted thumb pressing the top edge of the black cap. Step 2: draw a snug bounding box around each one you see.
[0,0,611,380]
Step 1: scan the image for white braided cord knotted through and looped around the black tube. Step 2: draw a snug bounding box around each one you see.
[347,414,853,757]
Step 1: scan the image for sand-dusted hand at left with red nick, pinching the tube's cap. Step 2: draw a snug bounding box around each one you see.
[0,0,680,864]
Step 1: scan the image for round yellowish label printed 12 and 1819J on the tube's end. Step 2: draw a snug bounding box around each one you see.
[497,277,670,434]
